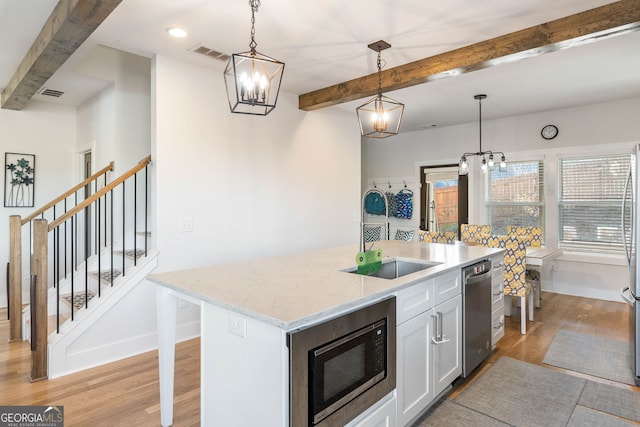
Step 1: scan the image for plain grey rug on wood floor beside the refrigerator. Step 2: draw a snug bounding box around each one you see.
[542,329,635,385]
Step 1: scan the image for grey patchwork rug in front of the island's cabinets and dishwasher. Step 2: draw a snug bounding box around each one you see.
[413,357,640,427]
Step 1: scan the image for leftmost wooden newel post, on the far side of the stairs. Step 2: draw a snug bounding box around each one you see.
[8,215,22,341]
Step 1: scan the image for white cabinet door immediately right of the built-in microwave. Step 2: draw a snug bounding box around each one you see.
[396,310,435,426]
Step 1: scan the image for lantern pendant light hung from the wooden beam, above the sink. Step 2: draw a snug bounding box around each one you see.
[356,40,404,138]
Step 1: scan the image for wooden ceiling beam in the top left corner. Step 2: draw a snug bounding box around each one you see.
[0,0,122,110]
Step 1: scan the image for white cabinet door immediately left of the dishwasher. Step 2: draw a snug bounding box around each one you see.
[431,295,462,396]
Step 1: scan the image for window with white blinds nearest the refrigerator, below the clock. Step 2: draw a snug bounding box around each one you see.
[558,155,631,253]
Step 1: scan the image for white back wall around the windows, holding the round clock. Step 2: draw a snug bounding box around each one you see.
[362,98,640,301]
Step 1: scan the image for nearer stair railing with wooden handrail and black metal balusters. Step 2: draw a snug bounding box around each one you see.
[31,156,151,378]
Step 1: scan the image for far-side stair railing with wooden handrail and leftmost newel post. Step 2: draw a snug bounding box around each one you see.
[7,162,114,341]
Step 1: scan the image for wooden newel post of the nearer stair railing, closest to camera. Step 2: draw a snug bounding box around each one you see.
[29,219,49,382]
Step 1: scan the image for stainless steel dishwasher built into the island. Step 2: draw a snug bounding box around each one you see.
[462,261,491,378]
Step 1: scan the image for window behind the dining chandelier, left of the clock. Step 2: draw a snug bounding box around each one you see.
[486,160,544,234]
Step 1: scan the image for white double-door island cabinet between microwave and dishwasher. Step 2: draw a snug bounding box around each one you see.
[396,271,462,426]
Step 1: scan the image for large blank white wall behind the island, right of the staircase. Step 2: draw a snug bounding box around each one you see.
[152,56,360,271]
